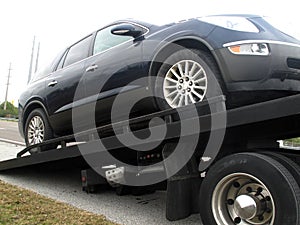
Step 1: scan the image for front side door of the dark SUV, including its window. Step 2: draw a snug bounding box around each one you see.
[84,23,147,123]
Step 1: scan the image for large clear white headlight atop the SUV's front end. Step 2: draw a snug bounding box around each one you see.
[198,16,259,33]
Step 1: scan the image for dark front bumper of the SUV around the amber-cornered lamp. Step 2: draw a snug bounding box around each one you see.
[215,41,300,92]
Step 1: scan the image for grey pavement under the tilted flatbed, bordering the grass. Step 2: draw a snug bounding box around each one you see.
[0,142,202,225]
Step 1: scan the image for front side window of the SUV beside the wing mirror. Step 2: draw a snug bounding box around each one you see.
[93,24,133,55]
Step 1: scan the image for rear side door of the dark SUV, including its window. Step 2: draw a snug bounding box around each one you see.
[46,35,92,134]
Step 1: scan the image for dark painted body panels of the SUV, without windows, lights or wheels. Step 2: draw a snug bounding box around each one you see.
[19,15,300,135]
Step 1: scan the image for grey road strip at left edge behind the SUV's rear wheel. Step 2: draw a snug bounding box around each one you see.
[0,120,24,145]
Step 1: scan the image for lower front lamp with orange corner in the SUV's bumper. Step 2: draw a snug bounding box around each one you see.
[228,43,270,55]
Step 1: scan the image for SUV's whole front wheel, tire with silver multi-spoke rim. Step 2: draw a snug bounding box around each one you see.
[154,49,224,110]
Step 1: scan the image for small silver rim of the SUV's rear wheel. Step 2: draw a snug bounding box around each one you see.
[27,116,45,145]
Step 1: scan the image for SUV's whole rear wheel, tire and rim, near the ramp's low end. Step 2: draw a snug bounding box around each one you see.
[25,109,56,154]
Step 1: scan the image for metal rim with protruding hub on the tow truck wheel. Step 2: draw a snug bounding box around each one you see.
[212,173,275,225]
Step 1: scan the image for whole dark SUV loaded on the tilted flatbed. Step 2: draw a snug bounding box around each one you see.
[19,15,300,148]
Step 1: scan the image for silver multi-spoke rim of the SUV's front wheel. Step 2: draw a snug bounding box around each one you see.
[163,60,207,108]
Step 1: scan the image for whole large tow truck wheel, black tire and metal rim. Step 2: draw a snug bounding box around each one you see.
[200,153,300,225]
